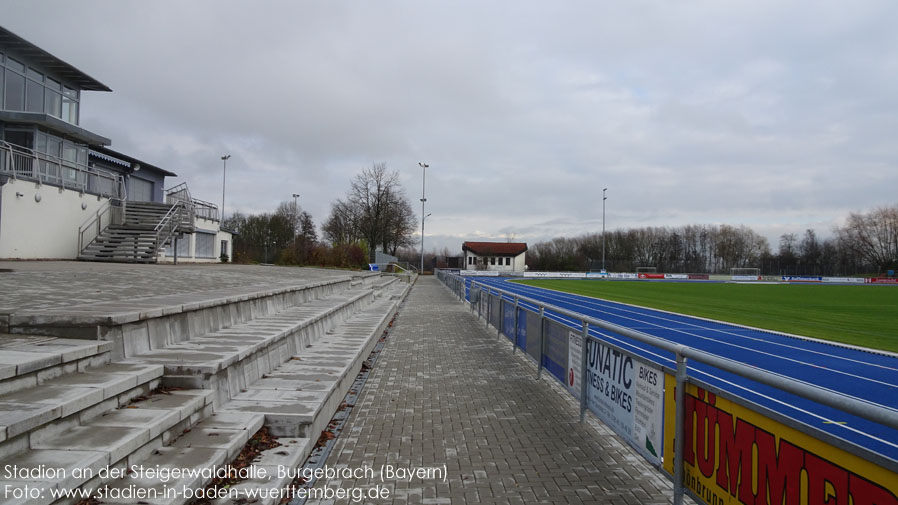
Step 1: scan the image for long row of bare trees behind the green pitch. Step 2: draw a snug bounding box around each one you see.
[527,205,898,276]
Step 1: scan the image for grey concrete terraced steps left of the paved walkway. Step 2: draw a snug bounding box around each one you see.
[0,278,409,504]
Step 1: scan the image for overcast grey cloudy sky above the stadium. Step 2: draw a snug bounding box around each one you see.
[0,0,898,252]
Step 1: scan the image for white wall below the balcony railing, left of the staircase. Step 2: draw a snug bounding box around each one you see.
[0,179,107,259]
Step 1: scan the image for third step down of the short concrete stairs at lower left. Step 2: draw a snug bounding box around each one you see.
[0,390,212,505]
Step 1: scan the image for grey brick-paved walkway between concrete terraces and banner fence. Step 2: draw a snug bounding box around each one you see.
[306,277,671,505]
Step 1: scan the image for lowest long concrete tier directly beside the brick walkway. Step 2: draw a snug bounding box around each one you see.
[221,286,407,438]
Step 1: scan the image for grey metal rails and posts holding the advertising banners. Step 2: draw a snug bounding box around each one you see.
[437,271,898,505]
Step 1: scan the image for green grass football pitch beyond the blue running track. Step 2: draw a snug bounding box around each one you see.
[519,280,898,352]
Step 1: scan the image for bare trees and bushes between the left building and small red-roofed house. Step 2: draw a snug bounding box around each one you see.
[222,163,415,268]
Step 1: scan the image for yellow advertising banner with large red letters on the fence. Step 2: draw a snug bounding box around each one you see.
[664,374,898,505]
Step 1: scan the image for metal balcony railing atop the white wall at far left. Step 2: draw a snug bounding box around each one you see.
[0,141,126,200]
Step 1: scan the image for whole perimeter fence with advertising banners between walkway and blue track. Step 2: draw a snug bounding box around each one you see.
[437,271,898,505]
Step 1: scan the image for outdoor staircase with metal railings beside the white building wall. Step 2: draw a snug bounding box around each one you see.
[78,183,196,263]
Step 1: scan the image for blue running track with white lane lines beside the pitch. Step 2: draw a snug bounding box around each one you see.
[467,277,898,461]
